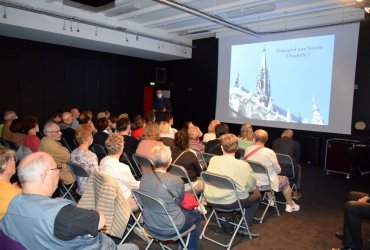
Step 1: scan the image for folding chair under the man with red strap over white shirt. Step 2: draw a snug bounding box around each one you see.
[247,160,280,223]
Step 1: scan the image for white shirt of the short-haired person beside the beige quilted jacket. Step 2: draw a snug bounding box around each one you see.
[100,155,140,199]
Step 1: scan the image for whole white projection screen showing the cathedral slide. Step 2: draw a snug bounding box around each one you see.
[216,24,359,134]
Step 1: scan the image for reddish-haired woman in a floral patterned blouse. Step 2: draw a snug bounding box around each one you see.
[71,124,99,196]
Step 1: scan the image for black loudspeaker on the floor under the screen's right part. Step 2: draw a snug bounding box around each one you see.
[301,136,321,166]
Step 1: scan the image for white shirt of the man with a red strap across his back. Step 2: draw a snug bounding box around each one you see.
[244,145,281,192]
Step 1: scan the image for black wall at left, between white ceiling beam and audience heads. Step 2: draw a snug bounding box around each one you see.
[0,37,155,121]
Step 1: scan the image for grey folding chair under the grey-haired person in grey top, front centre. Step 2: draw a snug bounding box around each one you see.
[132,189,195,250]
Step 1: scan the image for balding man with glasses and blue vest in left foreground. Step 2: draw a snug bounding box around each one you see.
[0,152,139,250]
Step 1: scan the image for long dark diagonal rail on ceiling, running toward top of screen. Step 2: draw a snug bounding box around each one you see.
[153,0,260,37]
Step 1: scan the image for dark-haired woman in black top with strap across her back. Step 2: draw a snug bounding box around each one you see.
[172,129,204,193]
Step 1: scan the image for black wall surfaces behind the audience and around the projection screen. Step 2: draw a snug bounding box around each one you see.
[0,23,370,164]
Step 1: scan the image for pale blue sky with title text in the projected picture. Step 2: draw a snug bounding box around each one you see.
[230,35,335,124]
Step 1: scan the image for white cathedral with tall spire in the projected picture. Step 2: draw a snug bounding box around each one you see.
[229,50,325,125]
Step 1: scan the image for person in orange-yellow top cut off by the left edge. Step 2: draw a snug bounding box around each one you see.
[0,148,22,220]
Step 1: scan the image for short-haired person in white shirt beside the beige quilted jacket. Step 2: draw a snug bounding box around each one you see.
[100,134,140,211]
